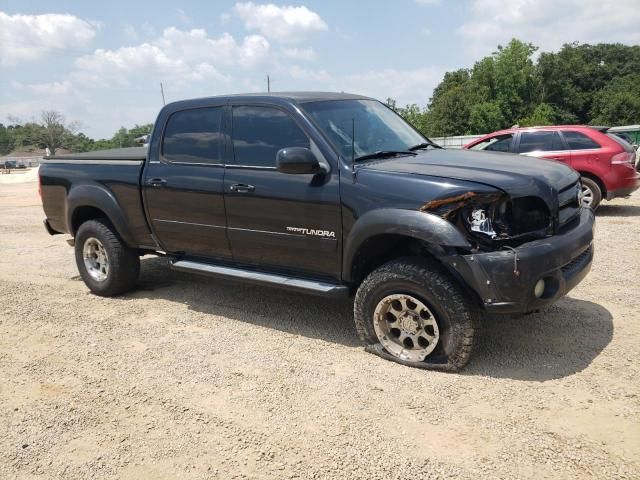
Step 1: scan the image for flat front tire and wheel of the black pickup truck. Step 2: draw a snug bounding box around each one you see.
[354,258,478,371]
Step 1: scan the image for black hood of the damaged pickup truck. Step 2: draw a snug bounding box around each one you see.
[360,149,579,200]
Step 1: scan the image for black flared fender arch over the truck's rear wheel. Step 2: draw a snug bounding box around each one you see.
[66,184,136,247]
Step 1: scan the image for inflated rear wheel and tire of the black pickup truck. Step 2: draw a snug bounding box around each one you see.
[75,219,140,297]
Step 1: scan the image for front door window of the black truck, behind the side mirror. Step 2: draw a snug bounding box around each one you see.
[232,106,310,168]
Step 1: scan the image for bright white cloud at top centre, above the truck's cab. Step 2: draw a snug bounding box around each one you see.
[235,2,329,42]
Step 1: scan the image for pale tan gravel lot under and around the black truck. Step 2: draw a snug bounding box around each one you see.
[0,183,640,479]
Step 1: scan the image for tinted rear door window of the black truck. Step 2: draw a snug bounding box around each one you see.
[162,107,223,164]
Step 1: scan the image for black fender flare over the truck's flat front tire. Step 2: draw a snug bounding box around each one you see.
[342,208,471,281]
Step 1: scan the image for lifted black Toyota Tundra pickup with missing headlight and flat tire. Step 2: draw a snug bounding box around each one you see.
[40,93,594,370]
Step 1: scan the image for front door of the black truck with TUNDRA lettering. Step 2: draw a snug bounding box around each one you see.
[224,105,341,278]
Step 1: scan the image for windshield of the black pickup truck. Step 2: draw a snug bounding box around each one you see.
[302,100,427,158]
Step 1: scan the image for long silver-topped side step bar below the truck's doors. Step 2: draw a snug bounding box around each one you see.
[169,260,349,298]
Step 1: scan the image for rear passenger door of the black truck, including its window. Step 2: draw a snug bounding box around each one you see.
[142,106,231,258]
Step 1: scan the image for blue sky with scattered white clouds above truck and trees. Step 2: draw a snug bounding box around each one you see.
[0,0,640,137]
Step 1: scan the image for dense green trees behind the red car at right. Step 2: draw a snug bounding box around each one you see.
[387,39,640,137]
